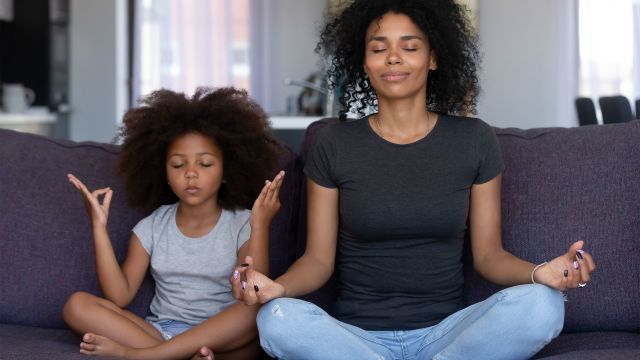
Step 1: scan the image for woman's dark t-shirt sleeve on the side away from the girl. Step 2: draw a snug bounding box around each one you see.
[473,120,504,184]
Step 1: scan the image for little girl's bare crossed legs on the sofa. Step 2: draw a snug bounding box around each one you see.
[63,292,260,359]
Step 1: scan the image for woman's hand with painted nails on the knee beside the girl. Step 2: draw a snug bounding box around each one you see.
[230,256,285,305]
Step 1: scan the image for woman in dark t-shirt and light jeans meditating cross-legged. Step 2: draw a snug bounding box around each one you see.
[234,0,595,359]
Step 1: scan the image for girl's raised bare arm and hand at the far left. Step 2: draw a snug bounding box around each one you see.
[68,175,149,307]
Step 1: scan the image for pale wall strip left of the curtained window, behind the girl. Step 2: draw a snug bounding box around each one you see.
[69,0,127,142]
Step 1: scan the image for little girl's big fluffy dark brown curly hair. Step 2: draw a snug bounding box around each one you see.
[118,88,286,210]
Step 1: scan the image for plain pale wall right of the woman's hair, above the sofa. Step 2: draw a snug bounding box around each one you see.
[477,0,578,128]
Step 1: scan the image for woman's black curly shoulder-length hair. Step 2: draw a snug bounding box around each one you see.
[316,0,480,119]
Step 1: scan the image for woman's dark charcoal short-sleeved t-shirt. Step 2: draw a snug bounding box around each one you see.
[304,115,504,330]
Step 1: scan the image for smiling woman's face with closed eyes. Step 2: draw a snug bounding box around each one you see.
[364,12,436,99]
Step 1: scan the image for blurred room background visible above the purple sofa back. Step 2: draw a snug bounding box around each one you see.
[0,0,640,147]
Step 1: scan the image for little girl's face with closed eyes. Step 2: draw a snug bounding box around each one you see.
[166,133,223,206]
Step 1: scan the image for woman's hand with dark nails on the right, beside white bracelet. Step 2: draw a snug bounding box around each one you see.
[534,240,596,290]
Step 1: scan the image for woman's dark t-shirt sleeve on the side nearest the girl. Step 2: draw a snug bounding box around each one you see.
[304,125,337,188]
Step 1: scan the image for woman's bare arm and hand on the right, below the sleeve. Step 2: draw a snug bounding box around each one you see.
[469,175,594,290]
